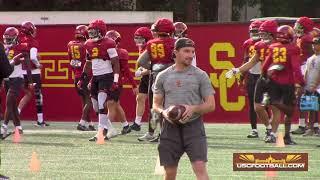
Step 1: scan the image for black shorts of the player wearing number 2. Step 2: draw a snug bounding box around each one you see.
[90,73,113,97]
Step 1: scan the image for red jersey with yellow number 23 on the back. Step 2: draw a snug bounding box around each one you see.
[262,42,303,85]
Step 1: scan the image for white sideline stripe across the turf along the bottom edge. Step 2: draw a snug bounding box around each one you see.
[3,169,317,179]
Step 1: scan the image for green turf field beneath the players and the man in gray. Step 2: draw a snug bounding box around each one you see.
[0,122,320,180]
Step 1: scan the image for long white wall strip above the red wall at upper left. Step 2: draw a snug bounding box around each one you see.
[0,11,173,25]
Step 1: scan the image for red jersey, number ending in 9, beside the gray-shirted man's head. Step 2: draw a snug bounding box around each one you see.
[147,37,175,64]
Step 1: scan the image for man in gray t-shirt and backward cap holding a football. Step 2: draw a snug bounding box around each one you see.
[153,38,215,180]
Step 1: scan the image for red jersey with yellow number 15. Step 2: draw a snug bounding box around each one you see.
[68,40,87,78]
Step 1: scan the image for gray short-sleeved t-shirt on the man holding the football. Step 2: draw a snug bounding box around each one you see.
[153,65,215,121]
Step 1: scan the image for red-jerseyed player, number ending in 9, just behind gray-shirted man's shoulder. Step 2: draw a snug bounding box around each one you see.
[138,18,175,142]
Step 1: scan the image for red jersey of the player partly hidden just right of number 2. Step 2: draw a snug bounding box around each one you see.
[117,48,137,88]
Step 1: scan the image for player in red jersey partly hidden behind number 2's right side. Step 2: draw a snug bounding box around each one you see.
[106,30,138,134]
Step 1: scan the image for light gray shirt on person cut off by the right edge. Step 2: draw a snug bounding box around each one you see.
[304,55,320,91]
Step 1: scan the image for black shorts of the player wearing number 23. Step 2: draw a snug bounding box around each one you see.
[268,80,296,105]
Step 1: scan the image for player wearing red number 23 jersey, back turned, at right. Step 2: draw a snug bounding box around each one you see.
[262,25,304,145]
